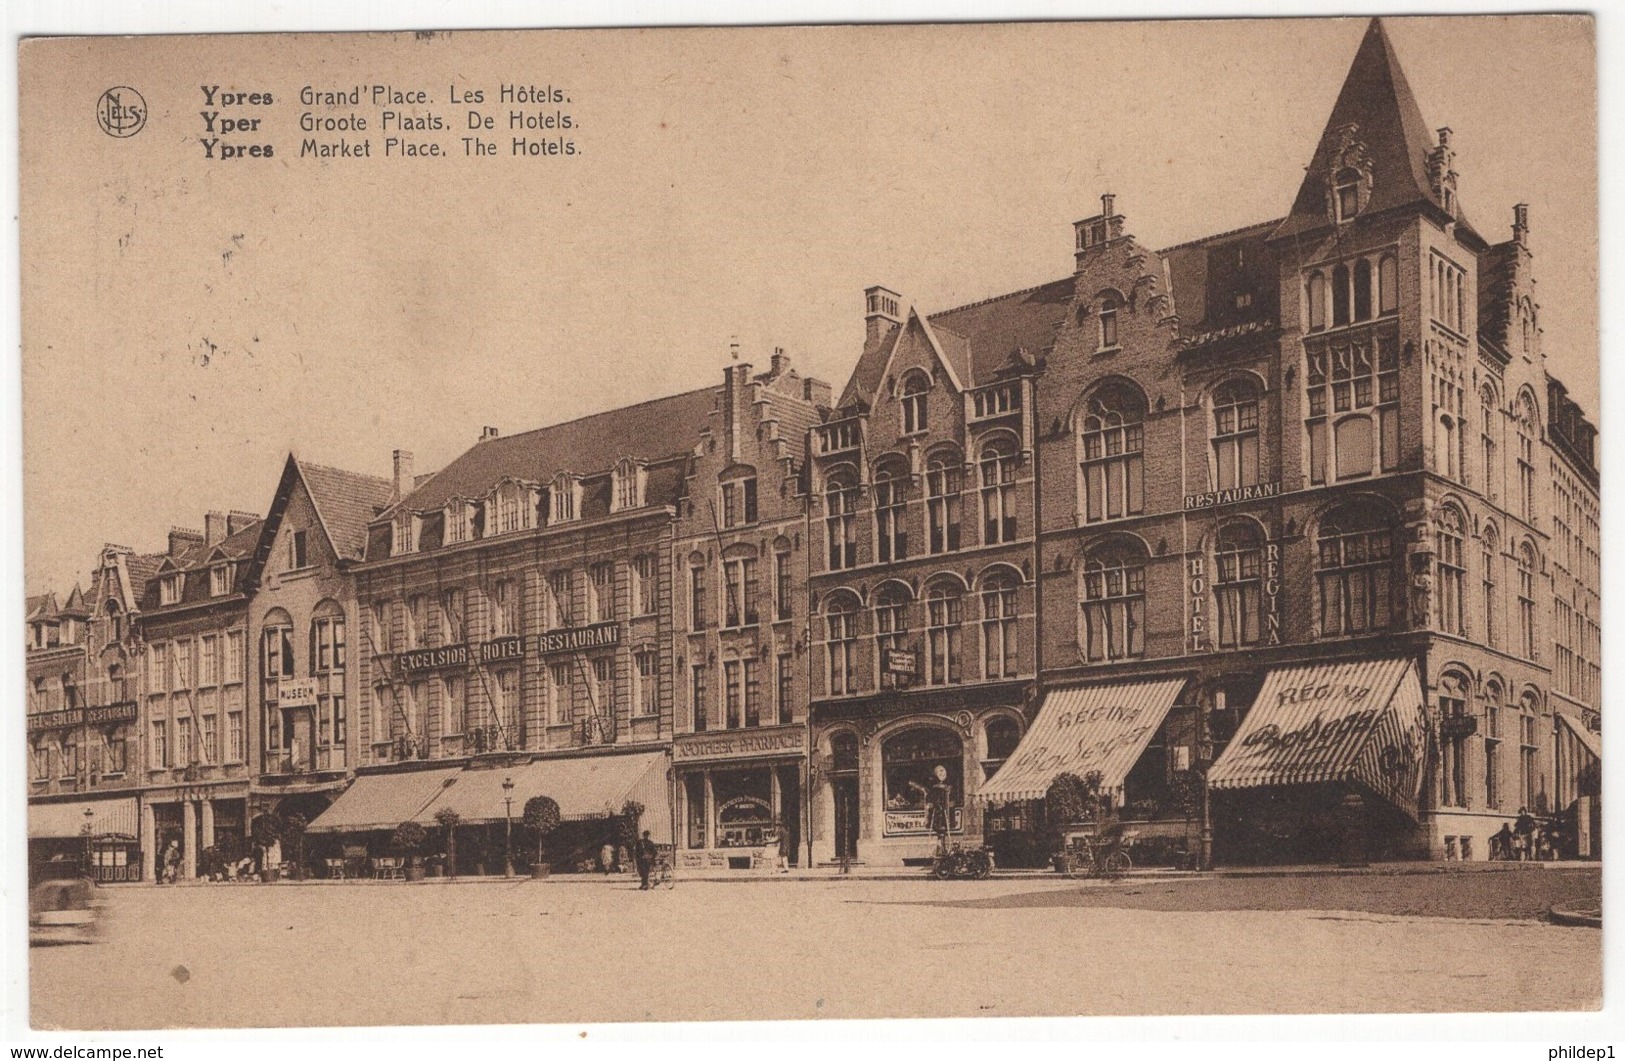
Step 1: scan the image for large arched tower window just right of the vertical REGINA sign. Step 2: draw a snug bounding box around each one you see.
[1316,502,1399,637]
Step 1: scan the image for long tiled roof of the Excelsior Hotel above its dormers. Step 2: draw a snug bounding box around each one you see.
[386,387,717,512]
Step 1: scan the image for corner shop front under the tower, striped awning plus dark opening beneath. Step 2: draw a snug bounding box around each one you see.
[1207,660,1423,863]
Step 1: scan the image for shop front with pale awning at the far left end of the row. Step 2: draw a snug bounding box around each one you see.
[28,796,141,884]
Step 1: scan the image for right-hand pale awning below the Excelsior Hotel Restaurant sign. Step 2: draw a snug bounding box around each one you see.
[416,752,671,843]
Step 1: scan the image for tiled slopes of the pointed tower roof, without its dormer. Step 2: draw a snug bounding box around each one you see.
[1276,18,1472,239]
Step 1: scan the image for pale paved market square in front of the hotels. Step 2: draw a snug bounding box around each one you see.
[31,871,1602,1029]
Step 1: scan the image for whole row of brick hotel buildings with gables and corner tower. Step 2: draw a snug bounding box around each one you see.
[29,21,1601,876]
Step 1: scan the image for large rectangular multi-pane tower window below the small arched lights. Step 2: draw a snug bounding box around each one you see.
[1305,335,1399,483]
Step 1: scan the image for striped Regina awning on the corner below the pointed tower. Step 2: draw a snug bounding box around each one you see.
[1207,660,1427,819]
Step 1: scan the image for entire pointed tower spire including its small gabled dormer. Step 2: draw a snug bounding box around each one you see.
[1274,18,1464,239]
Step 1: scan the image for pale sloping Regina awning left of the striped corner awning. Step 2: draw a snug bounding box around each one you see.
[975,678,1185,803]
